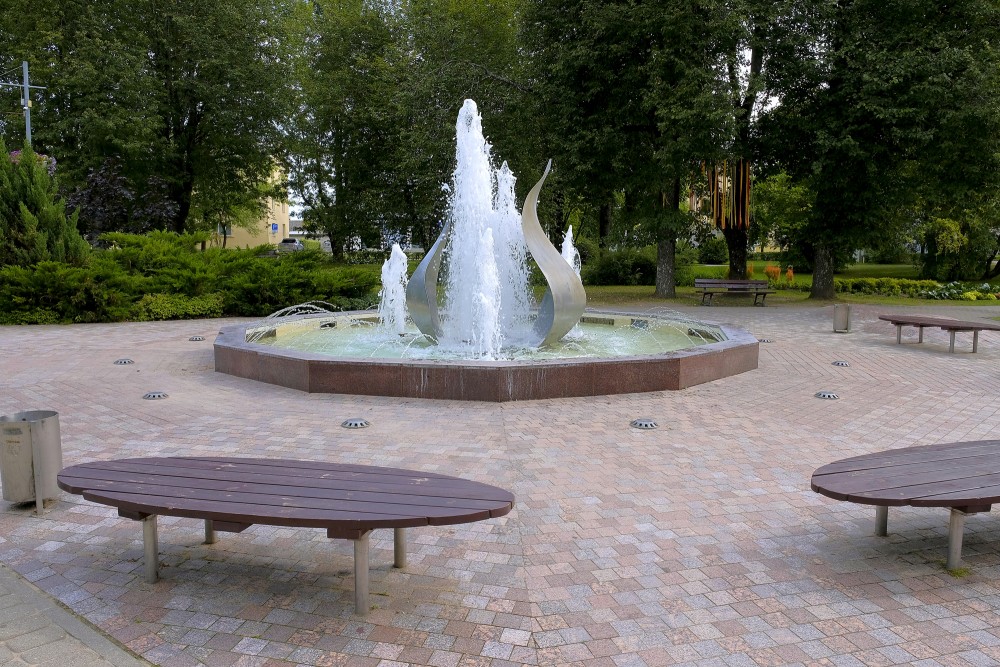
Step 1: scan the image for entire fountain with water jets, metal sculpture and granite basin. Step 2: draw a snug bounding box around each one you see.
[215,100,757,401]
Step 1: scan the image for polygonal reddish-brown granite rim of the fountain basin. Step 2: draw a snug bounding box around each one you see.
[215,311,758,402]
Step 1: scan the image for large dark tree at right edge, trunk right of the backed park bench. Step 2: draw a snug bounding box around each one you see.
[761,0,1000,298]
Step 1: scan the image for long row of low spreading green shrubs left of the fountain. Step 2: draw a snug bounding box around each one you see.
[0,232,380,324]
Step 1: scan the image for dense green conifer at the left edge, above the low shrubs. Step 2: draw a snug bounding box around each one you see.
[0,139,90,266]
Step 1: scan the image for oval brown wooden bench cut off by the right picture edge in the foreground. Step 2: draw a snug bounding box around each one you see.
[811,440,1000,570]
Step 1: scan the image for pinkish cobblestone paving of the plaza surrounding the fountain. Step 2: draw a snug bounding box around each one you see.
[0,306,1000,667]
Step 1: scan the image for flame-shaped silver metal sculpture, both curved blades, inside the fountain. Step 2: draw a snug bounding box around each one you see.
[406,160,587,347]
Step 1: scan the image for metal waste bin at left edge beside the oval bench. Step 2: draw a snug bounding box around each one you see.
[0,410,62,514]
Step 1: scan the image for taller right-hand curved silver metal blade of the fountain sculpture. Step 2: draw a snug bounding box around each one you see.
[521,160,587,347]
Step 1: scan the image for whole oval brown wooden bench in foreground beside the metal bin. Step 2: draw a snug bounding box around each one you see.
[57,457,514,615]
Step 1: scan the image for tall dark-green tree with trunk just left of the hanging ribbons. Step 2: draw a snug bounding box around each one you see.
[526,0,731,297]
